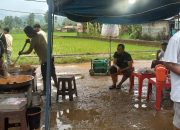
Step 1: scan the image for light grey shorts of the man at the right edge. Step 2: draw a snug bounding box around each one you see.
[173,102,180,129]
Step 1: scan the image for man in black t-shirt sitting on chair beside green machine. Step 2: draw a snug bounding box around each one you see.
[109,44,133,89]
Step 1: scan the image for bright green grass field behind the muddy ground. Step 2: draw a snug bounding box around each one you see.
[9,33,158,64]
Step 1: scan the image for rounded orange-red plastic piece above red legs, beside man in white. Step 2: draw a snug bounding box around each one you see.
[155,64,168,81]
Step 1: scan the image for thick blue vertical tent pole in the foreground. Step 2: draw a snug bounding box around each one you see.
[45,0,53,130]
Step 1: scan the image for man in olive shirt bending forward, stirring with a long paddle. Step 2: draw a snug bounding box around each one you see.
[19,26,57,94]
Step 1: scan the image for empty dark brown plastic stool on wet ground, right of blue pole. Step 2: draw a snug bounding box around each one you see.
[56,75,77,101]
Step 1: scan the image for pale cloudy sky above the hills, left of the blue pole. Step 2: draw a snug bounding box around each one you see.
[0,0,48,18]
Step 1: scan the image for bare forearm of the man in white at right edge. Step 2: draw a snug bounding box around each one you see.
[164,62,180,75]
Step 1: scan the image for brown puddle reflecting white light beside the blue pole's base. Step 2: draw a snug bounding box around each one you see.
[50,109,100,130]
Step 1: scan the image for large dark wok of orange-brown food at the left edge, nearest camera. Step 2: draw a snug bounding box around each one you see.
[0,75,34,92]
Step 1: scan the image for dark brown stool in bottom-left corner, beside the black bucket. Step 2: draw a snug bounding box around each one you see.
[0,107,27,130]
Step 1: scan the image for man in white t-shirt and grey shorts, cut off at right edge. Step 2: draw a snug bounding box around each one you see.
[164,31,180,130]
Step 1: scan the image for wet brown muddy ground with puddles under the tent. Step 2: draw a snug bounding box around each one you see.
[10,61,173,130]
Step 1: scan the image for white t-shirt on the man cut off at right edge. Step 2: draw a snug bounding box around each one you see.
[164,31,180,102]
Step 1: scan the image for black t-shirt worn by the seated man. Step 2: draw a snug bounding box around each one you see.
[113,52,132,68]
